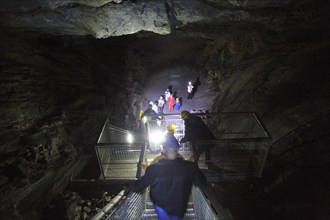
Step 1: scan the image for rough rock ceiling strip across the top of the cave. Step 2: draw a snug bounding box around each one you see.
[0,0,315,38]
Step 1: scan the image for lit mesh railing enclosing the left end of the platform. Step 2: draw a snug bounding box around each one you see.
[95,119,145,180]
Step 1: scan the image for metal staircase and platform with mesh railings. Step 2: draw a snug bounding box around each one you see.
[93,112,270,220]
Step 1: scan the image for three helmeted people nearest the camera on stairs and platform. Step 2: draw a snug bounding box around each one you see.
[126,111,215,220]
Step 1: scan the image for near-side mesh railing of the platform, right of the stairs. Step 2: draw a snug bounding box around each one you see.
[194,140,269,181]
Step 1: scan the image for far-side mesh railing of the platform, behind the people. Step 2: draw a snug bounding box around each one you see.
[147,112,270,151]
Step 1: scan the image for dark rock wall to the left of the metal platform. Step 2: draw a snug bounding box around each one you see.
[0,33,145,218]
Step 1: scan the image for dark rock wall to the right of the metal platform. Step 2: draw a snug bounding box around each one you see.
[201,28,330,189]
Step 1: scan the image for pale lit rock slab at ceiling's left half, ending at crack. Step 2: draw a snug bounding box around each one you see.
[2,1,170,38]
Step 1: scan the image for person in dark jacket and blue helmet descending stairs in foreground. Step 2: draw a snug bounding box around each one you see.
[126,146,206,220]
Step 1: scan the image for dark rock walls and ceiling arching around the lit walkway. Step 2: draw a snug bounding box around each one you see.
[0,0,330,219]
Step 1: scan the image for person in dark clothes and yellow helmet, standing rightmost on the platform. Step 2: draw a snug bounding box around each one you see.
[180,111,215,165]
